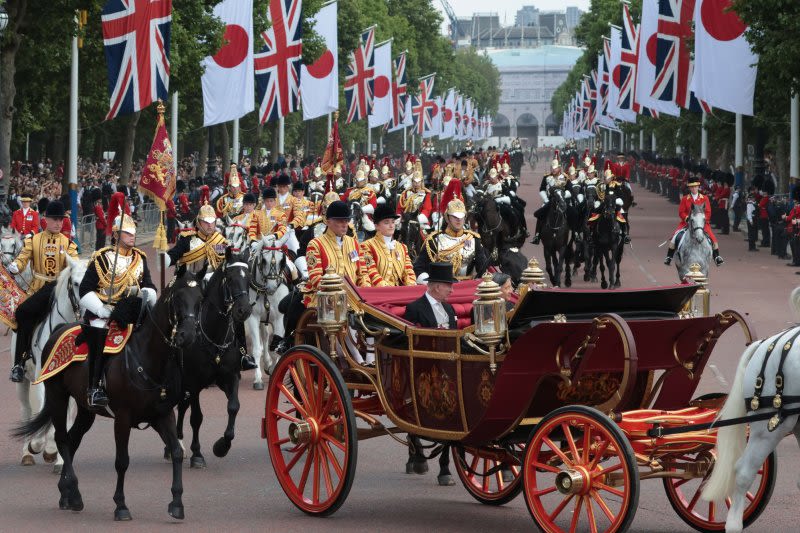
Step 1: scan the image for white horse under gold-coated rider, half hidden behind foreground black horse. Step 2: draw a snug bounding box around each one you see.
[11,256,87,473]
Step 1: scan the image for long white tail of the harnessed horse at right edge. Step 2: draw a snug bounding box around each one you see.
[702,338,764,501]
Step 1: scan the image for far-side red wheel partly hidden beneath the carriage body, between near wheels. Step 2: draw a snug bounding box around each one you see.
[453,444,525,505]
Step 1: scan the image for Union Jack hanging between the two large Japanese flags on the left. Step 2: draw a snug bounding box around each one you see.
[253,0,303,124]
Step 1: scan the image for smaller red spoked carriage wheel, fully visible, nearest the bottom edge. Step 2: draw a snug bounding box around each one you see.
[522,406,639,533]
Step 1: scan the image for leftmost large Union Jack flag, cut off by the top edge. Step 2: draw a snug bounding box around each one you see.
[100,0,172,120]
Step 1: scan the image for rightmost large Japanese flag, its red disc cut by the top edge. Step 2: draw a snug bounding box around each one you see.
[690,0,758,115]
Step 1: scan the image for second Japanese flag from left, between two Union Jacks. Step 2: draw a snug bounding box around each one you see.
[300,2,339,120]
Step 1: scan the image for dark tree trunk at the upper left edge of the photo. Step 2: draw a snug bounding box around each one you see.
[0,0,28,197]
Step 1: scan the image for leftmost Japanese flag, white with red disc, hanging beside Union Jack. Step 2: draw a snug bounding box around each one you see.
[201,0,256,126]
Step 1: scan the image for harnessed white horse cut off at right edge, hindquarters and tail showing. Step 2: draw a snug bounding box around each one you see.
[702,287,800,533]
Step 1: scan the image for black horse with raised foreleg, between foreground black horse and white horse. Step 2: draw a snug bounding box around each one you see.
[173,248,251,468]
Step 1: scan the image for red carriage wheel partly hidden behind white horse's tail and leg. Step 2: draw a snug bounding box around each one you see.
[662,453,778,533]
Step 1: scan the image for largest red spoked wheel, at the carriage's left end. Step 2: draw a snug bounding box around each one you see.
[265,346,358,516]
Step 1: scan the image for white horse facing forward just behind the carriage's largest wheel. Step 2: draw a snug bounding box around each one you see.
[244,230,297,390]
